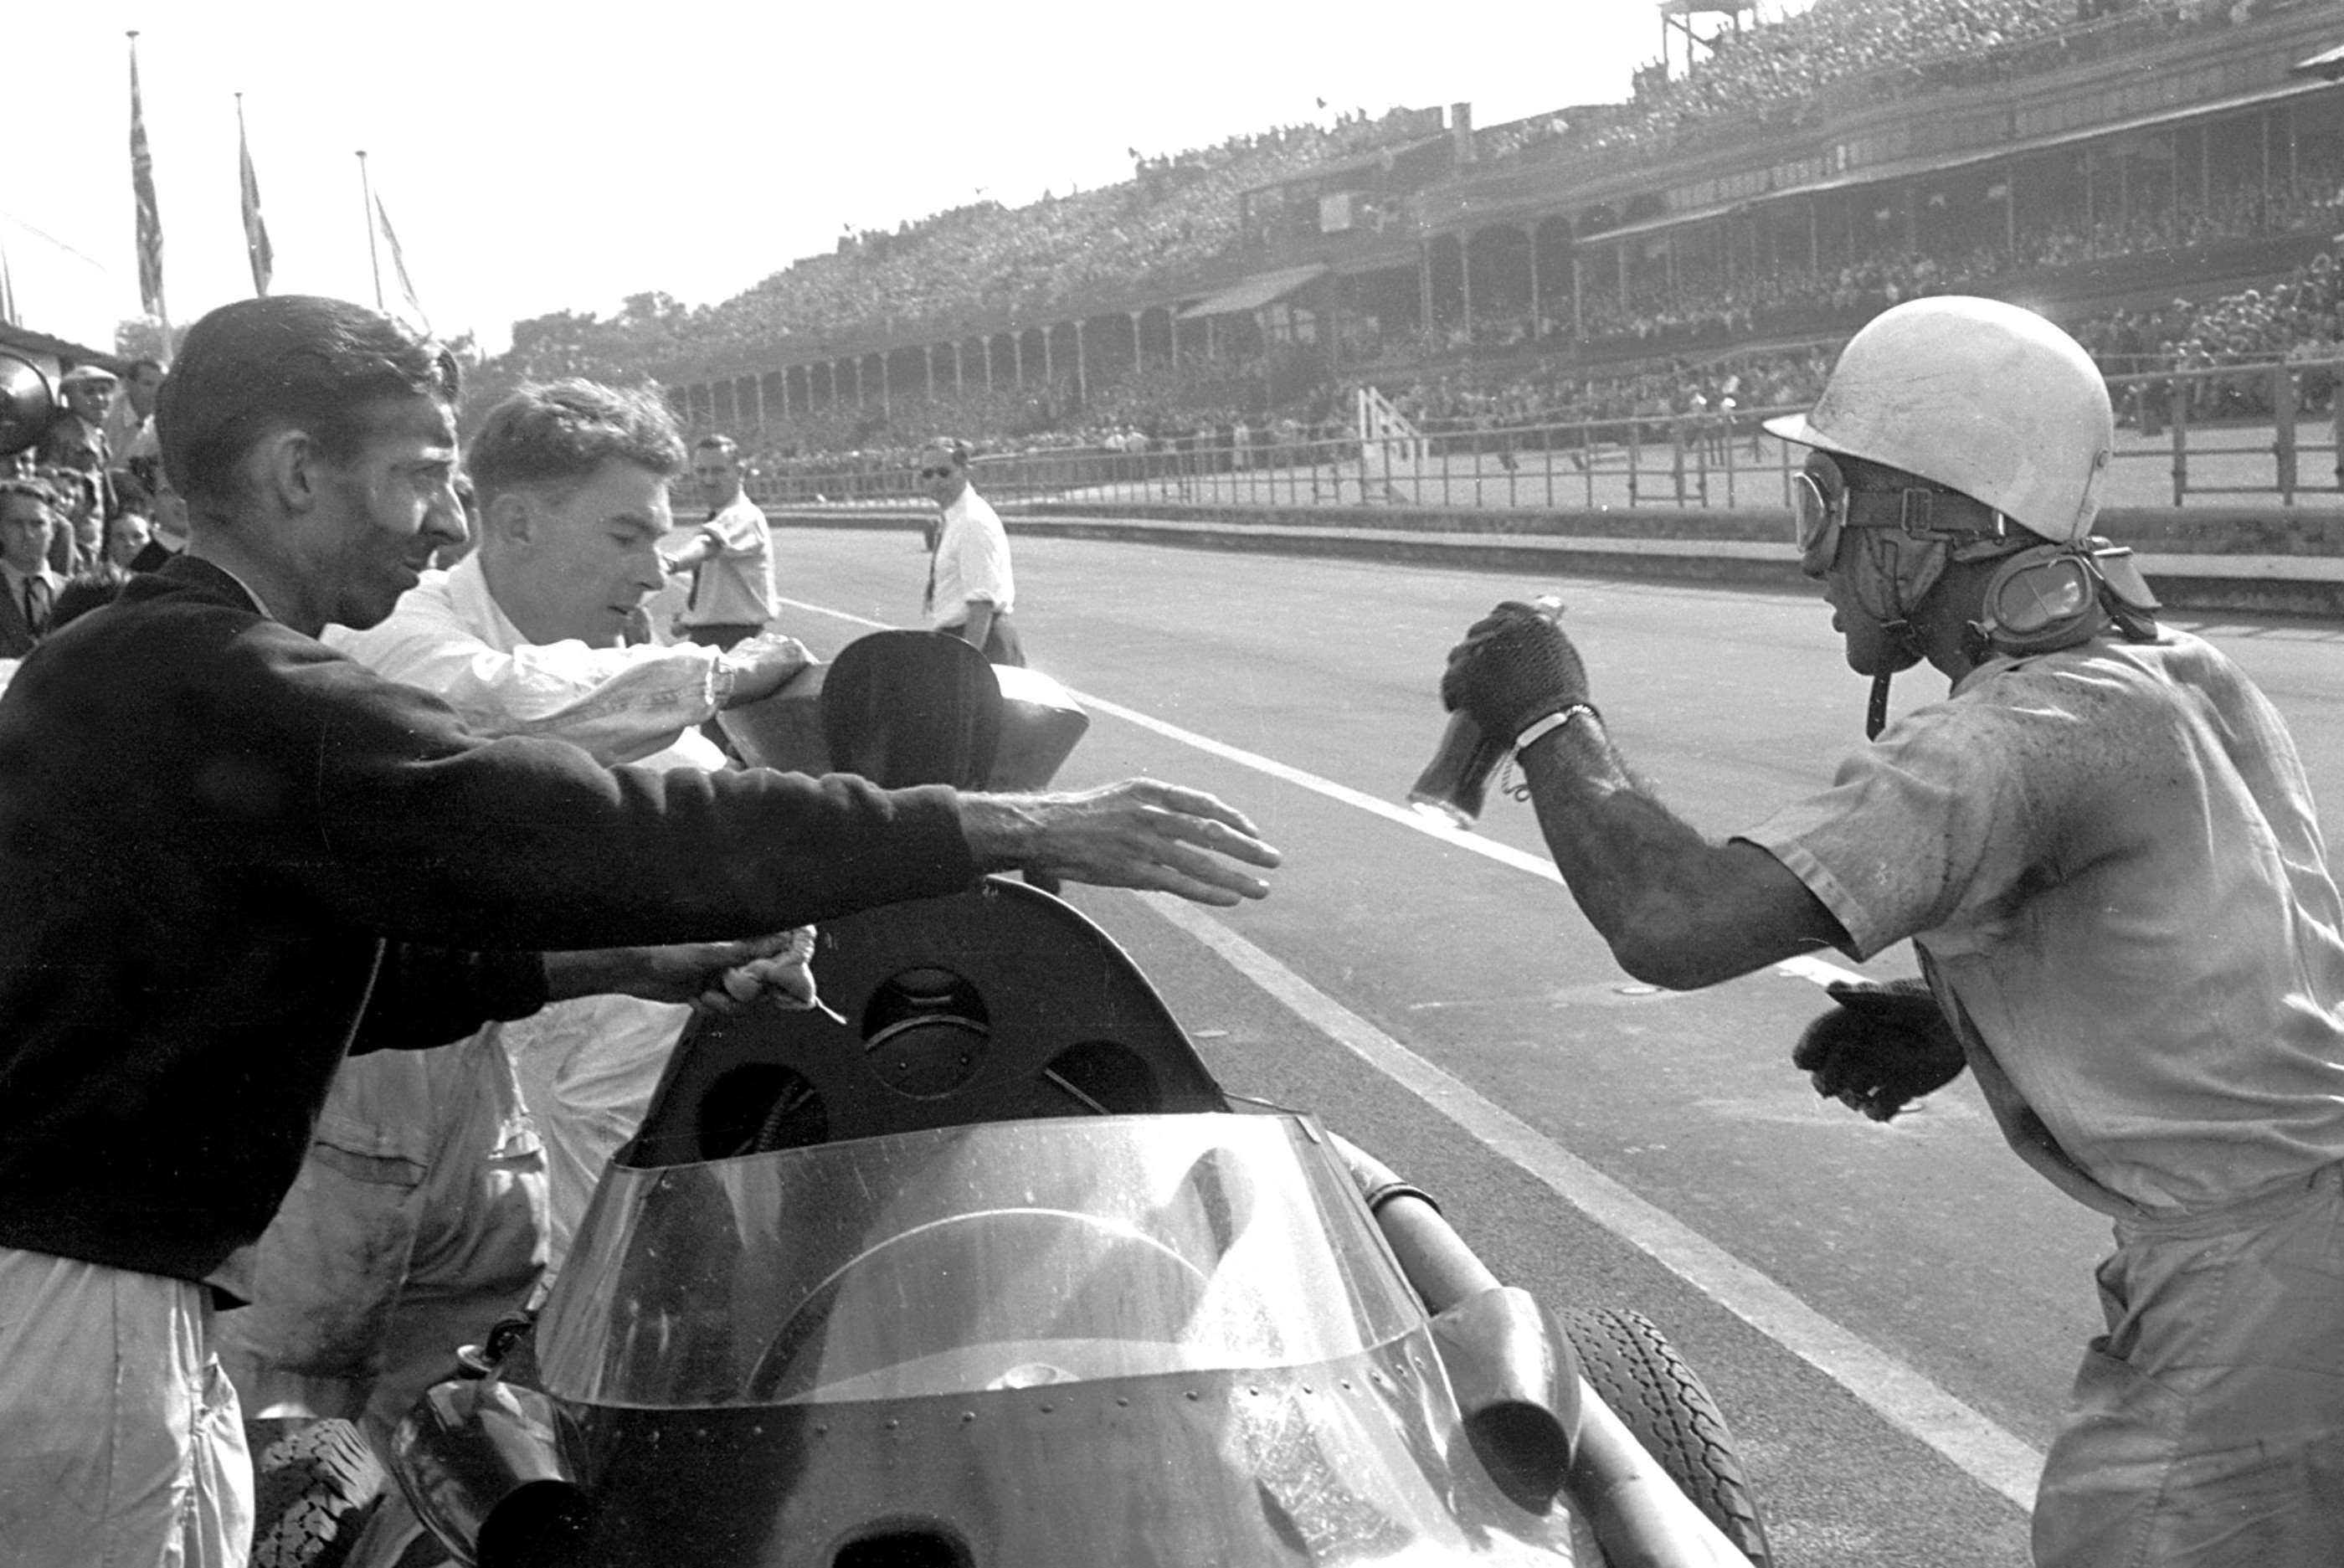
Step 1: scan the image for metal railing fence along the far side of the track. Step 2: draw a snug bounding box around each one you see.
[753,361,2344,511]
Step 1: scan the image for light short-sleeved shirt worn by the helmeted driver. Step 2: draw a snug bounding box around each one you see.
[1744,630,2344,1216]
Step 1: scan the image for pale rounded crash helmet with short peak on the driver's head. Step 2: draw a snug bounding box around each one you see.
[1765,296,2116,546]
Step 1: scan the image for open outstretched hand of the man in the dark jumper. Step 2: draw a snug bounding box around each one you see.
[961,779,1280,907]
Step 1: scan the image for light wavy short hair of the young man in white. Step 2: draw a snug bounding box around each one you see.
[464,380,685,511]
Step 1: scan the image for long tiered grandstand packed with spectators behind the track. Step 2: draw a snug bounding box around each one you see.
[499,0,2344,478]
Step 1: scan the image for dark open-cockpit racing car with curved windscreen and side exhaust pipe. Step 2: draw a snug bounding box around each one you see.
[365,633,1767,1568]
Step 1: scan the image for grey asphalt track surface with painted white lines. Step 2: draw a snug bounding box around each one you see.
[776,527,2344,1568]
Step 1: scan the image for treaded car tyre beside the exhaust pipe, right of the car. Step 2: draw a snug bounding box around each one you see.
[1561,1308,1775,1568]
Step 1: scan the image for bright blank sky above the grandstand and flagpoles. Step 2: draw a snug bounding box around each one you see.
[0,0,1706,352]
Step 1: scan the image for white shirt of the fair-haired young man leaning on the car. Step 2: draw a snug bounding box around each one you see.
[323,556,724,1275]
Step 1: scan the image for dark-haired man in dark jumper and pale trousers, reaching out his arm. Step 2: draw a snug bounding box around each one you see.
[0,296,1277,1568]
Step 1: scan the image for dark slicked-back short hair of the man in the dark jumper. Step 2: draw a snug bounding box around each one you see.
[155,293,462,504]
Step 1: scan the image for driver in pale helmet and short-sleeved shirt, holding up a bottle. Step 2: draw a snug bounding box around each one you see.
[1442,296,2344,1568]
